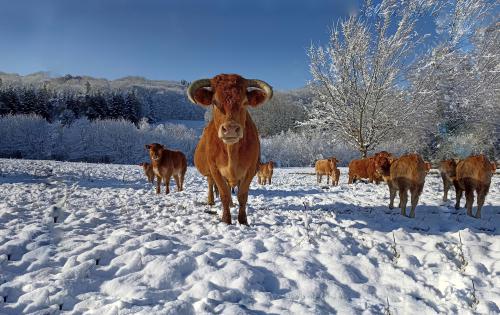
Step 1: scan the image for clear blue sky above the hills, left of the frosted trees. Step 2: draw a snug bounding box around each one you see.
[0,0,362,89]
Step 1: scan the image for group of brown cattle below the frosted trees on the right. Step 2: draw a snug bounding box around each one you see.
[315,151,496,218]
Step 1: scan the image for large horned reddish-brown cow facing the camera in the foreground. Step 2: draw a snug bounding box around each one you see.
[187,74,273,224]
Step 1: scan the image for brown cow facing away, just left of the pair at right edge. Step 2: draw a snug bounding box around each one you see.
[384,154,425,218]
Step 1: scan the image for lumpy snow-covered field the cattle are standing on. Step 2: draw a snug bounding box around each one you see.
[0,160,500,315]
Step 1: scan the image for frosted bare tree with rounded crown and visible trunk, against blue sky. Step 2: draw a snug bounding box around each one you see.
[305,0,442,157]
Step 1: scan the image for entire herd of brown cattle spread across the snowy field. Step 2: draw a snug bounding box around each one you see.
[140,74,496,225]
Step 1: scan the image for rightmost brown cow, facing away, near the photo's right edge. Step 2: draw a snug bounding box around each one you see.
[455,155,496,218]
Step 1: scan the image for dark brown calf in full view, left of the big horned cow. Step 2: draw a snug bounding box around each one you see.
[145,143,187,194]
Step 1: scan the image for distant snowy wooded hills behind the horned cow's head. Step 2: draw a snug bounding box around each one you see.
[0,72,312,136]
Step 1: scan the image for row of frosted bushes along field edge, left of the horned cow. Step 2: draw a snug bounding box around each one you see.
[0,115,198,163]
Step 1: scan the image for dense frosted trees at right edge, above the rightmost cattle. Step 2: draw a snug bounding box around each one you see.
[402,0,500,158]
